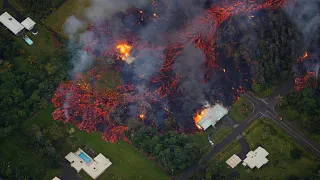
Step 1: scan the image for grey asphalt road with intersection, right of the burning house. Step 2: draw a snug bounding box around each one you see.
[179,80,320,180]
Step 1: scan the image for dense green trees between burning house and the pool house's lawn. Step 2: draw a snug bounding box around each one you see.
[126,119,200,174]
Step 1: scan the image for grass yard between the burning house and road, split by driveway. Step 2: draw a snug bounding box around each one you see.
[190,126,232,155]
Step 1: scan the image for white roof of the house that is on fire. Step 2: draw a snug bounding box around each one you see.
[197,104,228,130]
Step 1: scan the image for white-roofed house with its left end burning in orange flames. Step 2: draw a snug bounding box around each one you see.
[194,104,228,130]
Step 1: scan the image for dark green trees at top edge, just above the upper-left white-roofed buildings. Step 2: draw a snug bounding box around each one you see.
[18,0,65,20]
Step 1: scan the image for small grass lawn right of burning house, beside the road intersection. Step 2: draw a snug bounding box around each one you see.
[229,97,253,123]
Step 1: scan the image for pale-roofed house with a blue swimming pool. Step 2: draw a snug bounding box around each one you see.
[65,148,112,179]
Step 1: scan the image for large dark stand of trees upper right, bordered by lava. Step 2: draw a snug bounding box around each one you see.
[217,11,303,94]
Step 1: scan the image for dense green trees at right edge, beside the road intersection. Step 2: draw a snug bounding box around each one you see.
[278,79,320,139]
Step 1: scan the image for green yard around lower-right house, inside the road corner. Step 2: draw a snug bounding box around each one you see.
[212,118,317,180]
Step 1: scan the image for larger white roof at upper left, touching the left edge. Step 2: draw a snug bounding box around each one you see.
[0,12,24,35]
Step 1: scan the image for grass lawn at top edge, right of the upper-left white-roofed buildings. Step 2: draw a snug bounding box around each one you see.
[45,0,91,34]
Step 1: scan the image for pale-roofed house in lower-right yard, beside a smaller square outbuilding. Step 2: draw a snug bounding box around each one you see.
[242,146,269,169]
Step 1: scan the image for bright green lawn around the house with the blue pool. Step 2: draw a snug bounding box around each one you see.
[21,105,169,179]
